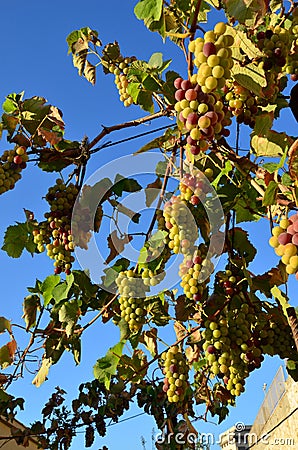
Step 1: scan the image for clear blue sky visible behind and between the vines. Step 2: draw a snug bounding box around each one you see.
[0,0,297,450]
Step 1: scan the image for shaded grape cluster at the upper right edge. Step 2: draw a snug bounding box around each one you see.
[256,18,298,81]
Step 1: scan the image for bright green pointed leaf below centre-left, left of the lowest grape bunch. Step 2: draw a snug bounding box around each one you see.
[93,341,126,389]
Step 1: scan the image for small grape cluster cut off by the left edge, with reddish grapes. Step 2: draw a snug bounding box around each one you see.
[0,146,28,195]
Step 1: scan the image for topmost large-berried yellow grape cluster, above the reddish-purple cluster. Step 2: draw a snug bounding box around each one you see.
[189,22,234,93]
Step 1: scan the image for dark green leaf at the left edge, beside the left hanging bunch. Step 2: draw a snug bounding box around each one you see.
[2,222,36,258]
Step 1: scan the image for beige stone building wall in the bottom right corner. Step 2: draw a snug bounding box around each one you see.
[250,376,298,450]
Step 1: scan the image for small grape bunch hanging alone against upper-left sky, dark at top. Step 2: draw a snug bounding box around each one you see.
[102,43,136,106]
